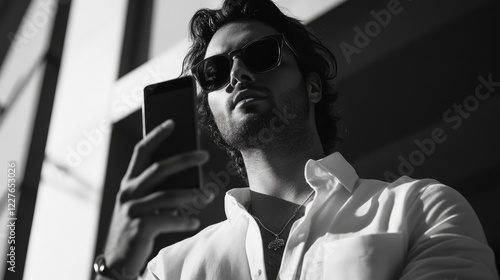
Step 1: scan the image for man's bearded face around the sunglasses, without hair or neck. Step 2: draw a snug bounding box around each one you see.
[205,21,309,149]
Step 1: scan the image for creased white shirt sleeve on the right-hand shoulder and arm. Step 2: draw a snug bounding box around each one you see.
[400,184,498,280]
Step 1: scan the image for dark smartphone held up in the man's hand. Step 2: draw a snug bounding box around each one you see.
[142,76,202,191]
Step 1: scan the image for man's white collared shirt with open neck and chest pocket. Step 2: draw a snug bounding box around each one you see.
[143,153,498,280]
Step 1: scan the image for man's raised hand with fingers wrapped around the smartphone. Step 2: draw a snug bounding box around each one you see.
[100,120,214,279]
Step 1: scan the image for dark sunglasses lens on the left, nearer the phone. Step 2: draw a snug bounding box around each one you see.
[196,56,231,90]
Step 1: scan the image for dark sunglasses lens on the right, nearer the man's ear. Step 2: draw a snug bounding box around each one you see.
[244,38,280,72]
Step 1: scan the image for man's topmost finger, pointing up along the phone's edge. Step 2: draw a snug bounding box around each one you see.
[125,120,175,177]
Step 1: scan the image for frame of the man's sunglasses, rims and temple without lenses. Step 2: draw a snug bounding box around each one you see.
[191,33,300,92]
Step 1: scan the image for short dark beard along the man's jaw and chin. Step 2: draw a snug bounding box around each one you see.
[215,81,311,151]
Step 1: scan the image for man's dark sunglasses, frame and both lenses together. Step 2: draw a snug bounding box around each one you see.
[191,33,300,91]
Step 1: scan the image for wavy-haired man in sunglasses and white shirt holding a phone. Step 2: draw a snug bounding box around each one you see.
[98,0,498,279]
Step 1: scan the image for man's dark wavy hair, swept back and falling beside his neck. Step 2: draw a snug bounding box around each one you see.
[182,0,342,181]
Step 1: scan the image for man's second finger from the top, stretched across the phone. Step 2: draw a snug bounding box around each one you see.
[131,151,209,196]
